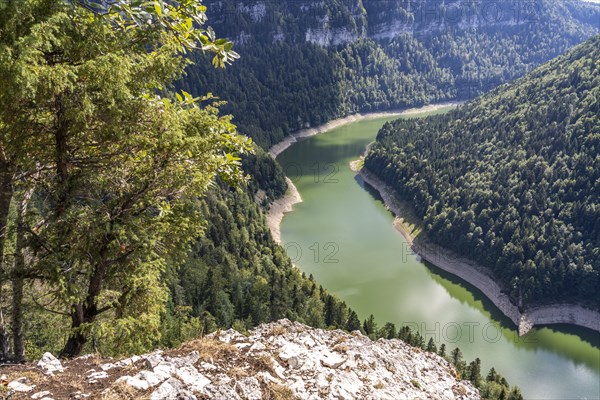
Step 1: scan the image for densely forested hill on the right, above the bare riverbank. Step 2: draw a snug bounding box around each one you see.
[365,36,600,308]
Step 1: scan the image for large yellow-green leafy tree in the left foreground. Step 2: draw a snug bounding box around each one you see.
[0,0,252,356]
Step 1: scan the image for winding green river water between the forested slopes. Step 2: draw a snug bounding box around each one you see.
[278,108,600,399]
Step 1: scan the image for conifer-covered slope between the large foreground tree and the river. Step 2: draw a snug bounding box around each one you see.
[166,183,348,345]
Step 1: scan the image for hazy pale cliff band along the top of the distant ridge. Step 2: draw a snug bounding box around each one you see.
[205,0,600,46]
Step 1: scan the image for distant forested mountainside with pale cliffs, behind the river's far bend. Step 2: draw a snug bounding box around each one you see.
[178,0,600,148]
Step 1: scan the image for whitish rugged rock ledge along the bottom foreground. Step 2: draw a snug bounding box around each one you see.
[3,319,480,400]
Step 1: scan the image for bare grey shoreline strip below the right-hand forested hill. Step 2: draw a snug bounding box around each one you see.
[352,163,600,336]
